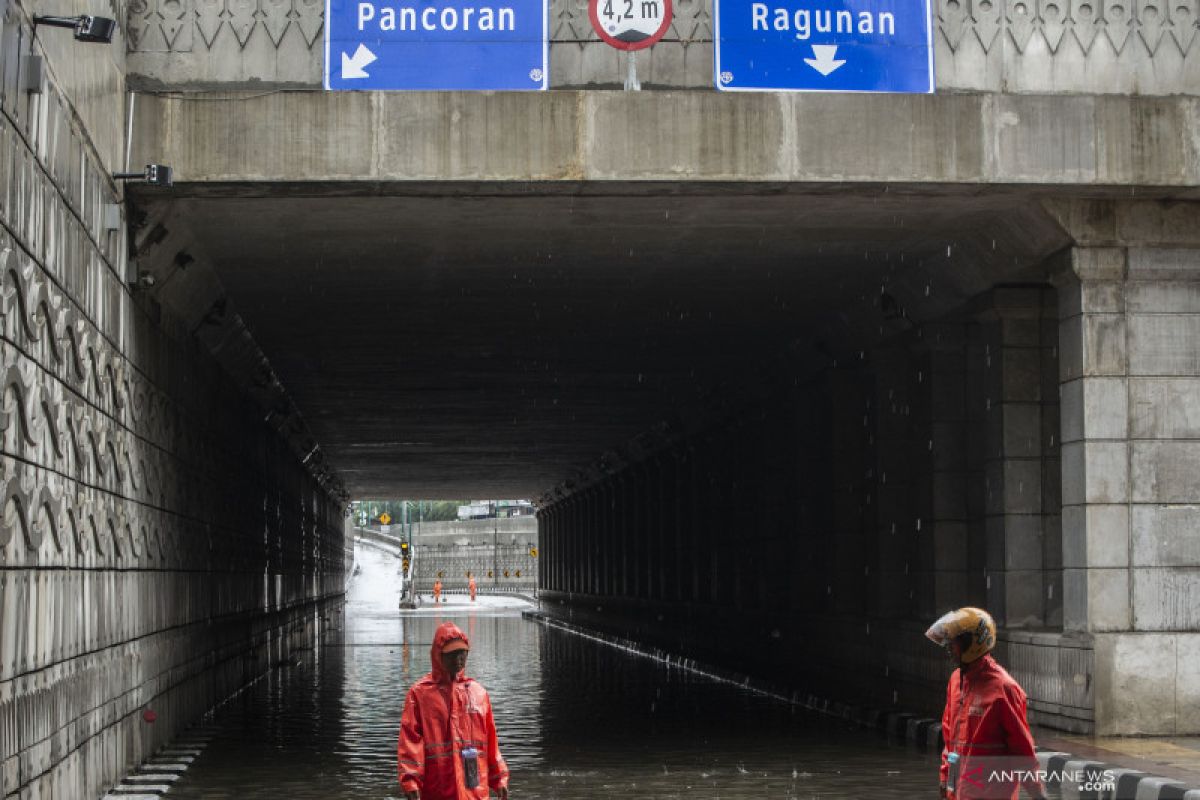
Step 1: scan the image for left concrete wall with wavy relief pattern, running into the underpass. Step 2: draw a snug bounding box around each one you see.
[0,4,344,798]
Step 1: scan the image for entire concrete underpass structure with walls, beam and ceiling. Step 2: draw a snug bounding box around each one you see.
[0,0,1200,796]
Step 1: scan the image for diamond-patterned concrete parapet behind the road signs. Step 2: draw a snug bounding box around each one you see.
[119,0,1200,95]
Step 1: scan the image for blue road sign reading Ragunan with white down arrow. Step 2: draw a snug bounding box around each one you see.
[713,0,934,92]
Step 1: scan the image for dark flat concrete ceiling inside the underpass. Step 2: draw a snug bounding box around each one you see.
[139,185,1067,498]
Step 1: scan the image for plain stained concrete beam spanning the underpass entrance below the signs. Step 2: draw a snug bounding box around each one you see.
[132,91,1200,190]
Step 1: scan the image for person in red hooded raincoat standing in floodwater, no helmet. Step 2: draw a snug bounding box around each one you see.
[398,622,509,800]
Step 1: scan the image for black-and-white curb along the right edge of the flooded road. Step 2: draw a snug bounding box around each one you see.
[521,610,1200,800]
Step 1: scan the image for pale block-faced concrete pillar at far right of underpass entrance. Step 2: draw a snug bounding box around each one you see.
[1060,241,1200,735]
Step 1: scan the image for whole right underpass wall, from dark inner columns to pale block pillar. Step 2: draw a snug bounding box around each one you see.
[539,200,1200,735]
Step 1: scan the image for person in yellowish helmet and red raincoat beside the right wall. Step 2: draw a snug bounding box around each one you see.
[925,608,1045,800]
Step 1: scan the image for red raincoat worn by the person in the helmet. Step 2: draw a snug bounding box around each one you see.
[941,655,1042,800]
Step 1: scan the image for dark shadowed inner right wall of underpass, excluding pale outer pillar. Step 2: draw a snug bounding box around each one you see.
[539,287,1094,730]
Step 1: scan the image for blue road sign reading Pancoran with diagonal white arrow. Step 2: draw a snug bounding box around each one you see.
[325,0,550,91]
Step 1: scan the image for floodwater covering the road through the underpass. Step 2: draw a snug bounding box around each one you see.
[169,547,937,800]
